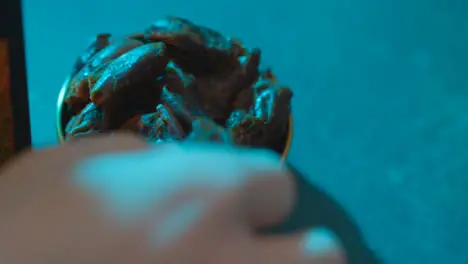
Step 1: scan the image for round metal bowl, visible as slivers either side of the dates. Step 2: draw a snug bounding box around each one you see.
[56,76,293,160]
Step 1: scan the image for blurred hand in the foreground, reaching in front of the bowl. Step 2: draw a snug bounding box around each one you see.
[0,135,344,264]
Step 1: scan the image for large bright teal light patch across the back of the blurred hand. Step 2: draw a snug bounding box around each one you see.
[74,143,282,222]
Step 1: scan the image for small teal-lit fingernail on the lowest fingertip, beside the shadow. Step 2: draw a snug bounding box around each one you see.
[303,228,340,257]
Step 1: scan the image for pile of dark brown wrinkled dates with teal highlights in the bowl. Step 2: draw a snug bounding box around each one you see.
[65,17,292,152]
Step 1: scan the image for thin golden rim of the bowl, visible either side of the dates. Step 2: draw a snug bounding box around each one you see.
[55,76,294,161]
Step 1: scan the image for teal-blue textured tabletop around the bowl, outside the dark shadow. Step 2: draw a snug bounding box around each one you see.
[23,0,468,264]
